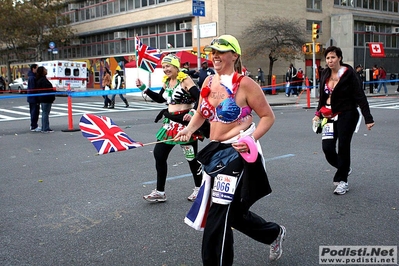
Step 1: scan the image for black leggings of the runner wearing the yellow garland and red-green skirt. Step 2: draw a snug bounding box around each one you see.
[154,141,202,191]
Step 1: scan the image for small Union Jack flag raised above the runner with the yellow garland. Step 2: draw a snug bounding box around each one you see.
[136,37,161,72]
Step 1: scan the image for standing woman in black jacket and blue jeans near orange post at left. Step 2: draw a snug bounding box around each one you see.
[35,66,55,133]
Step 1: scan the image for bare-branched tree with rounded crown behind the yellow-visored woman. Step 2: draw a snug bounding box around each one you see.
[242,17,306,85]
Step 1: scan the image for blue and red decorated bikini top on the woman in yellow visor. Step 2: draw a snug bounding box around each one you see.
[200,72,252,124]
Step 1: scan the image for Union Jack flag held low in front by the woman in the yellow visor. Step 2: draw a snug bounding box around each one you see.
[79,114,143,154]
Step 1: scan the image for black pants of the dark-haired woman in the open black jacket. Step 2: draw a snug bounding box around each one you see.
[322,109,359,182]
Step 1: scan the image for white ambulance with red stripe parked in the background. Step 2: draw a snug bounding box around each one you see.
[36,60,87,91]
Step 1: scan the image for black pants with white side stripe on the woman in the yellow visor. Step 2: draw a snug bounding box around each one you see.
[202,158,280,266]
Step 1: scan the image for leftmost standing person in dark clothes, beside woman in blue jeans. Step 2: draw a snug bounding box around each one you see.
[27,64,43,132]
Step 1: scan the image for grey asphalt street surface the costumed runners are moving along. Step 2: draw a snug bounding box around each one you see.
[0,90,399,266]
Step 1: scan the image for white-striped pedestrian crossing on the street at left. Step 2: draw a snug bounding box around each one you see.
[0,101,165,122]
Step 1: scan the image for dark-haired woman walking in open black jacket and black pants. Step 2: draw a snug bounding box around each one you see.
[313,46,374,195]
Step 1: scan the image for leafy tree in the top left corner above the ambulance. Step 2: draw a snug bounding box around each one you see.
[0,0,74,80]
